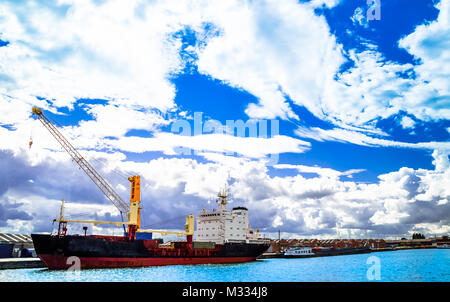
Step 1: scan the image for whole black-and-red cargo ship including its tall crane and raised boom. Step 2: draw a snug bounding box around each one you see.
[29,107,269,269]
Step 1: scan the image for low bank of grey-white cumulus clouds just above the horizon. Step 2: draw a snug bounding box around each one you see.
[0,144,450,237]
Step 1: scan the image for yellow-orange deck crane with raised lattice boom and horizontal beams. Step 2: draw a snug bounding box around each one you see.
[32,107,194,241]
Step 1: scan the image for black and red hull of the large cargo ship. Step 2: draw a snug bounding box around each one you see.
[31,234,268,270]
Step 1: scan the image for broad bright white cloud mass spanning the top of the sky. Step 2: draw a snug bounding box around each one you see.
[0,0,450,151]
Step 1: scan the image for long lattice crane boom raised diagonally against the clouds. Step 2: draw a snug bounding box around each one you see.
[32,107,130,214]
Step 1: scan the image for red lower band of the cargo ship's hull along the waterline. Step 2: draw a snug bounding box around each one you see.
[38,255,256,269]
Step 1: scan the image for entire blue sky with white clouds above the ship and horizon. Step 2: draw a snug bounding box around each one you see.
[0,0,450,236]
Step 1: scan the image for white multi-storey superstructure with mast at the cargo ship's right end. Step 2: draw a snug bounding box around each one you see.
[196,189,261,244]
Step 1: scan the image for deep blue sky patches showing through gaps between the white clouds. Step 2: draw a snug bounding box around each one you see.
[37,1,450,182]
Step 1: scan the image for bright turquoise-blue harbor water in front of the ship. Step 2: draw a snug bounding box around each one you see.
[0,249,450,282]
